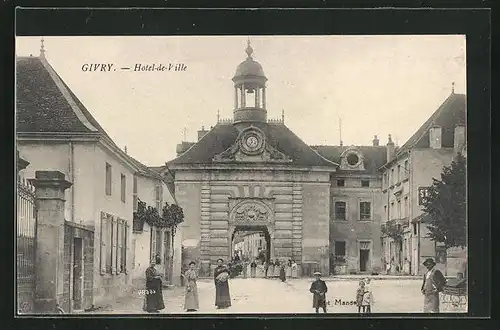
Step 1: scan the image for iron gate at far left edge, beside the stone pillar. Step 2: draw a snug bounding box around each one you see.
[16,179,37,314]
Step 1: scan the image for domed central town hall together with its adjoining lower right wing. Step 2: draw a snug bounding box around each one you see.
[160,42,387,276]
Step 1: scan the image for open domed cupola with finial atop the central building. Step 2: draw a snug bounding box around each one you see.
[233,40,267,124]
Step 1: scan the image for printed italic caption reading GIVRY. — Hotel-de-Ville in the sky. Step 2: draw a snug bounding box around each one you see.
[82,63,187,72]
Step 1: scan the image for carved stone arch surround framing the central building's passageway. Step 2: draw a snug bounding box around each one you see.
[228,198,275,260]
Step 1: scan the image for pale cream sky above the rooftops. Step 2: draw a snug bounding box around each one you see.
[16,35,466,166]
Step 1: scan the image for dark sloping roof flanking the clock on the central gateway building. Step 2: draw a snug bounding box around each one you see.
[167,123,338,167]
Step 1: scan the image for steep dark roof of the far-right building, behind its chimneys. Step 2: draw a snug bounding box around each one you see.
[396,93,467,155]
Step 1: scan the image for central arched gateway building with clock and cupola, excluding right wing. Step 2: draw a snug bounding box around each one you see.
[164,44,385,276]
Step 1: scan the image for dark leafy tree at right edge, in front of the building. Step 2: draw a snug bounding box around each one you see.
[422,154,467,248]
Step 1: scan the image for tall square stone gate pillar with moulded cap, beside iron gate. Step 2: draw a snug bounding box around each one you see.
[32,171,72,314]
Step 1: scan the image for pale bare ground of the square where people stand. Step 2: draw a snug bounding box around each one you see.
[82,277,467,314]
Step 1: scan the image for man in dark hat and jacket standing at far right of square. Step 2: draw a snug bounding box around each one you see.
[421,258,446,313]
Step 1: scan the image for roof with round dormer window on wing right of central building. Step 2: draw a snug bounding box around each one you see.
[311,146,387,174]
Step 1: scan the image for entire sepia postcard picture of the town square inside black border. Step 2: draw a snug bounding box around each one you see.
[15,34,468,316]
